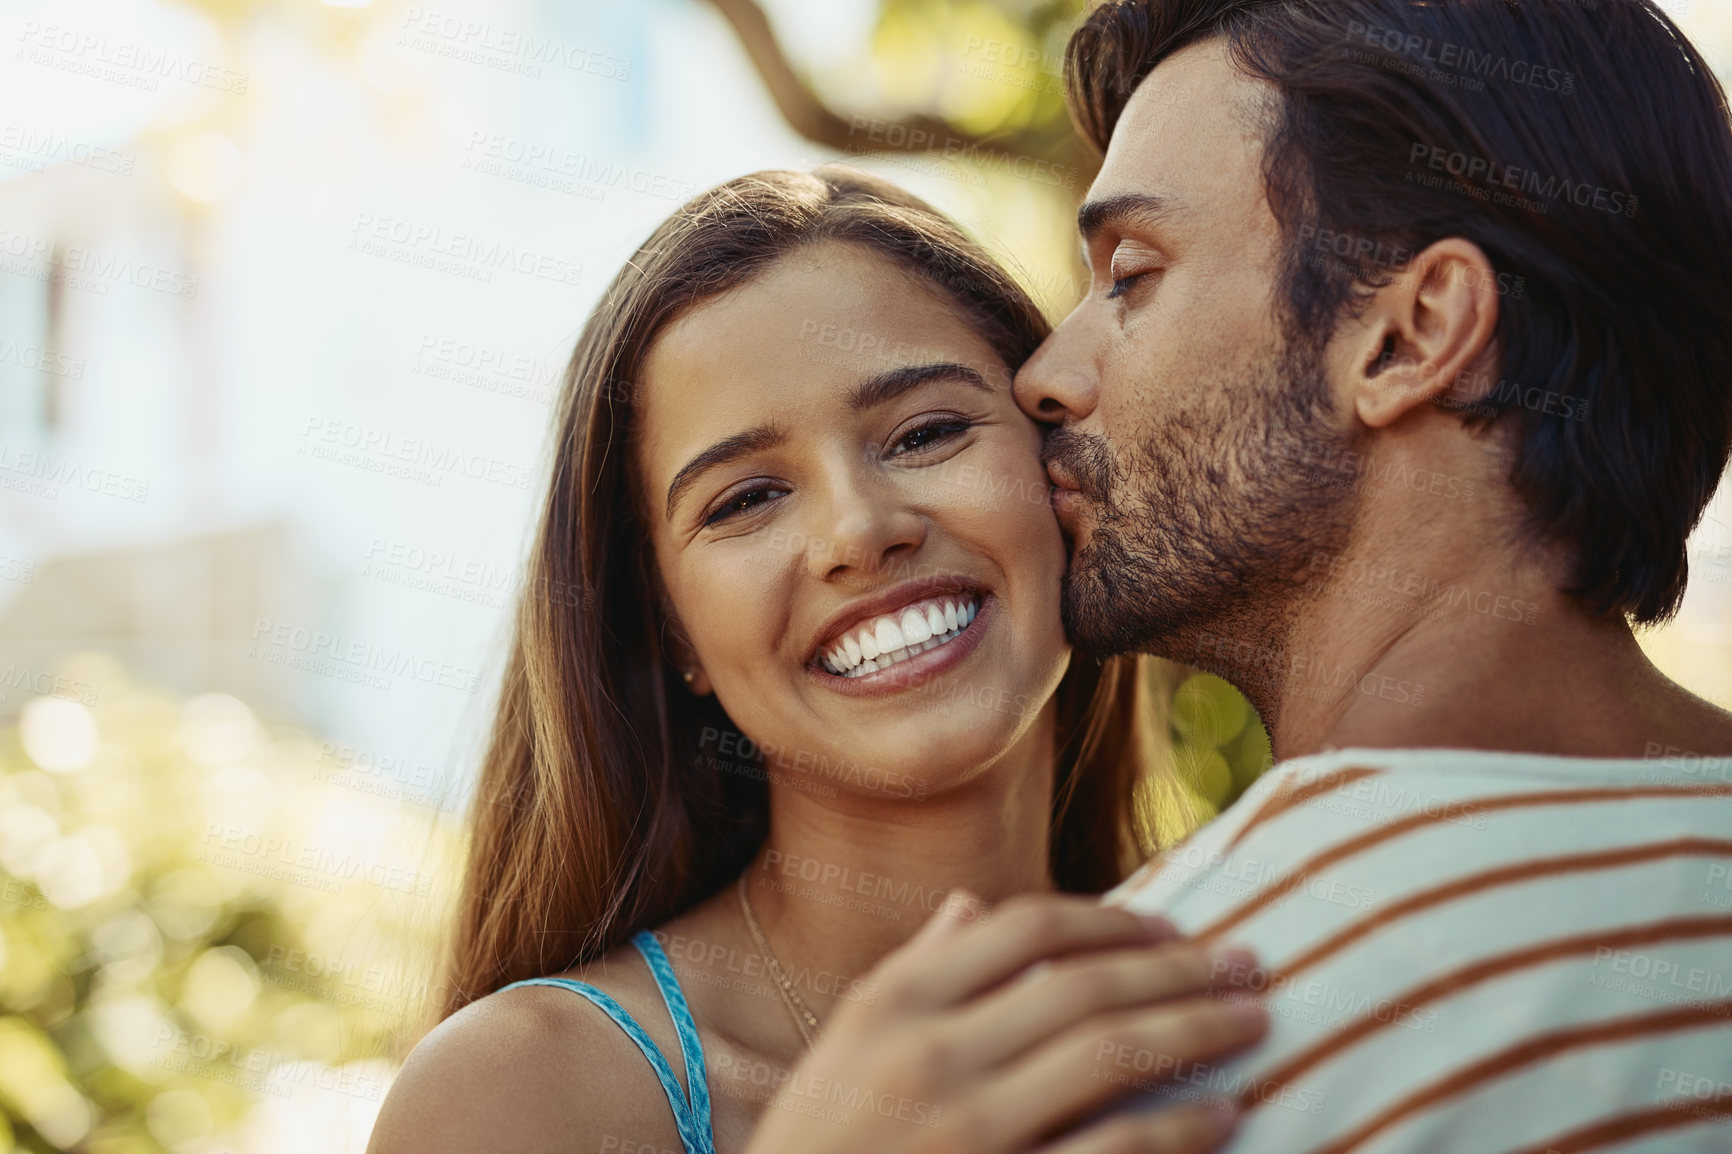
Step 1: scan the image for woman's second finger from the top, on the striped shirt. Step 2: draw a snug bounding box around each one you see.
[951,943,1256,1069]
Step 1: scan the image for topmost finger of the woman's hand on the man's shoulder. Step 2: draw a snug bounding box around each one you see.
[875,894,1176,1014]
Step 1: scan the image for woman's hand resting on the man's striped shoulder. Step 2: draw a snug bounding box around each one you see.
[746,894,1266,1154]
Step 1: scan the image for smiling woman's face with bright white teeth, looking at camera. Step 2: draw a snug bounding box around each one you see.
[637,244,1069,797]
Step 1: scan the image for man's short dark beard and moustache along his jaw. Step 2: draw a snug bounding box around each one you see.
[1044,327,1358,682]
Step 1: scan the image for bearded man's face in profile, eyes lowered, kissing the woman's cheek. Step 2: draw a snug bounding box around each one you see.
[1017,40,1353,667]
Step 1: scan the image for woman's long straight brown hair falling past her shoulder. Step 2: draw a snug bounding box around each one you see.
[438,168,1143,1019]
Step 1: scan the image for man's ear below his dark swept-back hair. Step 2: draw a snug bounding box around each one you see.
[1332,237,1498,428]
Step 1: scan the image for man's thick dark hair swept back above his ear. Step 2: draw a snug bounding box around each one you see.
[1067,0,1732,624]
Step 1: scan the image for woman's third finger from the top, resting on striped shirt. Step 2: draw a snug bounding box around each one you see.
[965,996,1268,1149]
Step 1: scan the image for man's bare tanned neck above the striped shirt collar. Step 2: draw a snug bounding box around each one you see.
[1249,537,1732,759]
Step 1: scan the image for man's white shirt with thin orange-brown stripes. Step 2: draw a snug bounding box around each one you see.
[1100,750,1732,1154]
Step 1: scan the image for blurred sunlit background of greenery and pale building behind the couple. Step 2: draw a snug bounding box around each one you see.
[0,0,1732,1154]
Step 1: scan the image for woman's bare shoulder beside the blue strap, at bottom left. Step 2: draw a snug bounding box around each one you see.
[367,953,681,1154]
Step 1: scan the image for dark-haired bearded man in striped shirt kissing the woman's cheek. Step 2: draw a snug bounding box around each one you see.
[1017,0,1732,1154]
